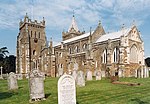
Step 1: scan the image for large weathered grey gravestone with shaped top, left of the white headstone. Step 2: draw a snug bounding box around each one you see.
[29,69,45,102]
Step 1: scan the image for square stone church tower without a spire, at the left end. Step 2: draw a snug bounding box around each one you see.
[16,14,47,74]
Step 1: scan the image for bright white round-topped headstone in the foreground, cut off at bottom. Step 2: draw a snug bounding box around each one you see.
[58,74,76,104]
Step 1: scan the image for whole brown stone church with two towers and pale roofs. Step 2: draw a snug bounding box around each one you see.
[16,15,149,78]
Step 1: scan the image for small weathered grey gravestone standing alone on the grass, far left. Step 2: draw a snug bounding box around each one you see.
[7,72,18,90]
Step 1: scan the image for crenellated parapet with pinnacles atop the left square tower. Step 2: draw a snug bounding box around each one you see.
[19,14,45,29]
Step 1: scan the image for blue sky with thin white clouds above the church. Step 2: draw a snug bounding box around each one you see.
[0,0,150,57]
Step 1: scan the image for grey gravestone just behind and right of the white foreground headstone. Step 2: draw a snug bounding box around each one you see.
[76,71,85,87]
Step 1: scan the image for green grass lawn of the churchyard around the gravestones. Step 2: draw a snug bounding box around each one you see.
[0,78,150,104]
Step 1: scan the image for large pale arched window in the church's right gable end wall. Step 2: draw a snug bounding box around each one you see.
[130,45,138,63]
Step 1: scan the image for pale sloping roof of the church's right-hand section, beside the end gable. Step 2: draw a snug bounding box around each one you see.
[96,28,131,43]
